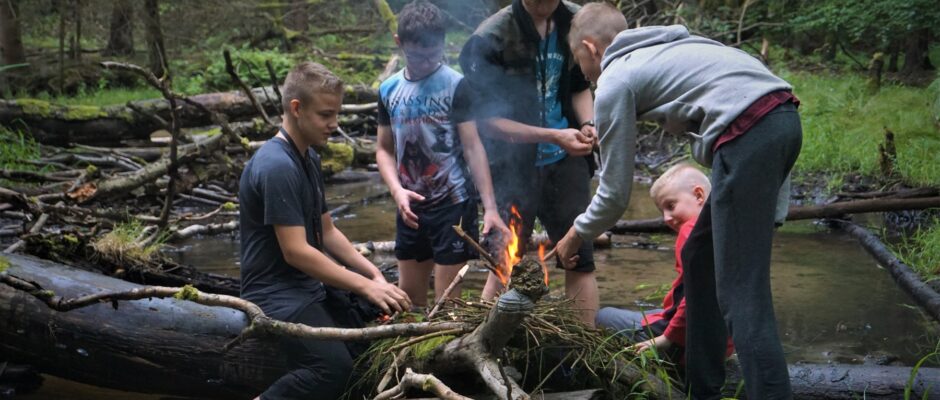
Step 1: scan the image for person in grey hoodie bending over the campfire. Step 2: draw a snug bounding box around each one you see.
[556,3,802,399]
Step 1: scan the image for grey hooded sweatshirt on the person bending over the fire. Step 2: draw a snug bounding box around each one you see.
[575,25,791,240]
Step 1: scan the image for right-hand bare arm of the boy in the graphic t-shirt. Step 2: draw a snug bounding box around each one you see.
[457,121,510,237]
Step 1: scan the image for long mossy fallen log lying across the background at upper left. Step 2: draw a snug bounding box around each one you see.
[0,86,378,145]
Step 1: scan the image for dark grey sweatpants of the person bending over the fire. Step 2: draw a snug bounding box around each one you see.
[681,103,802,400]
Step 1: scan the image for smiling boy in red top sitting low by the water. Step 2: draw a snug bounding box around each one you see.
[595,163,734,360]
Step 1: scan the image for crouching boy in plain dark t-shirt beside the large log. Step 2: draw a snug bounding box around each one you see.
[238,62,411,400]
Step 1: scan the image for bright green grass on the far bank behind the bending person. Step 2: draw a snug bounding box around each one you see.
[780,71,940,186]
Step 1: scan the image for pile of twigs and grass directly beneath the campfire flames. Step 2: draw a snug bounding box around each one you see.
[348,260,676,399]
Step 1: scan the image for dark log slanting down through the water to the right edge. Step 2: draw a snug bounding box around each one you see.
[829,220,940,324]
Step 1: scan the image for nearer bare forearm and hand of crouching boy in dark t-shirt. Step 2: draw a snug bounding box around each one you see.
[274,224,411,313]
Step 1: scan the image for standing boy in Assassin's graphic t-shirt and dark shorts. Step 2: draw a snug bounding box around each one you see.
[376,1,509,307]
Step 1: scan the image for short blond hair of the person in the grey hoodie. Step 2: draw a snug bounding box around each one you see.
[568,2,628,49]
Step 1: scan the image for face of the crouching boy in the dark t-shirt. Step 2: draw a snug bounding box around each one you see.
[291,92,343,147]
